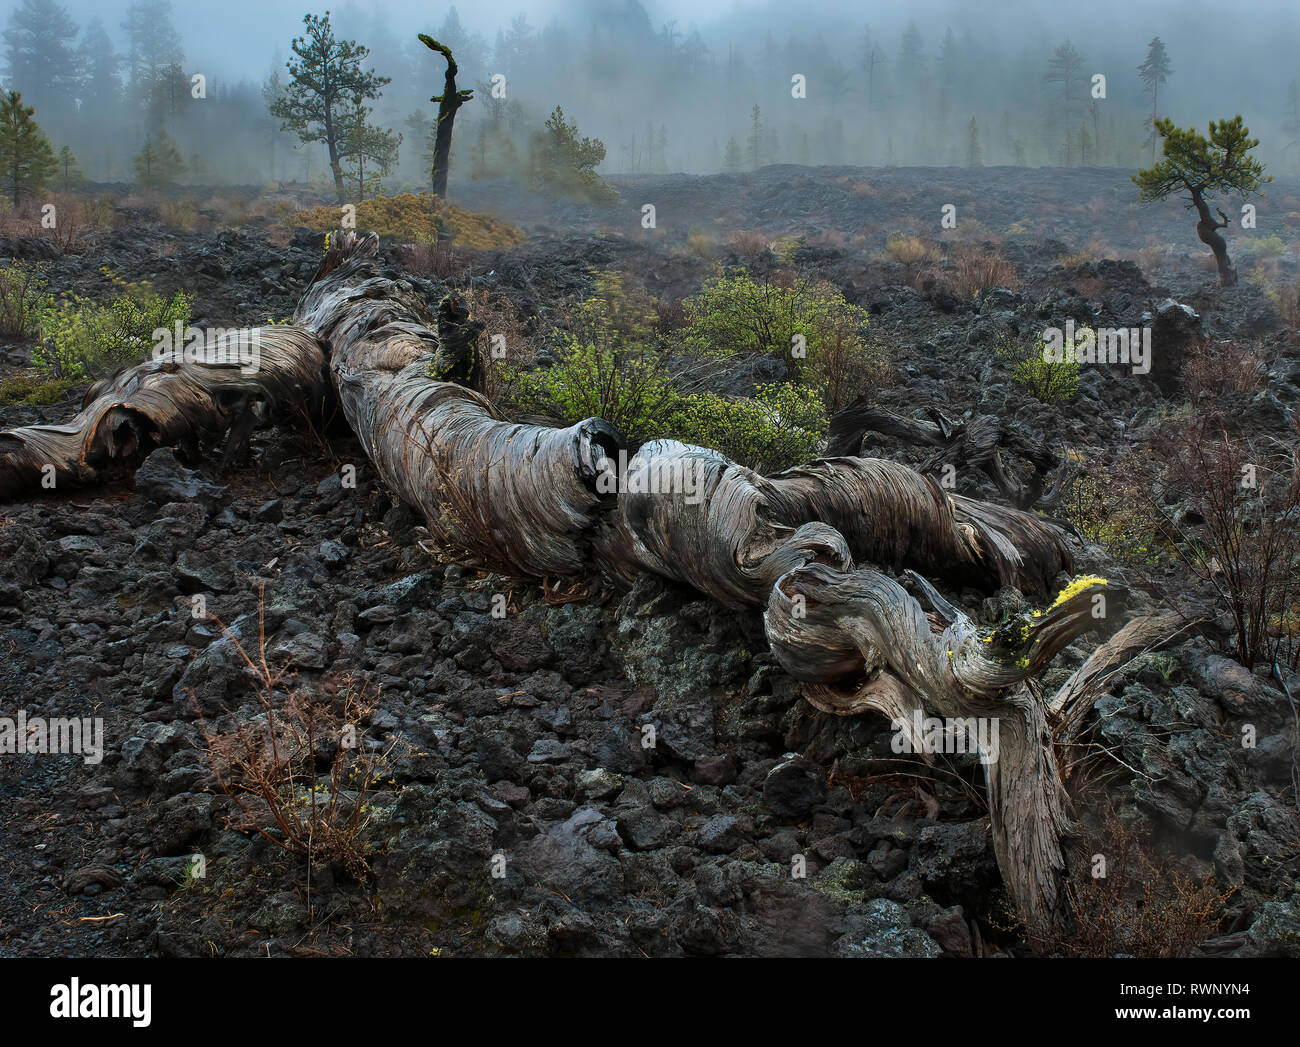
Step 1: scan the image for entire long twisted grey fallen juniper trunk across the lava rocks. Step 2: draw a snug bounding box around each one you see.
[0,233,1196,942]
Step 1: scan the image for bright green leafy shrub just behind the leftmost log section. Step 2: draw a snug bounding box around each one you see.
[31,278,191,378]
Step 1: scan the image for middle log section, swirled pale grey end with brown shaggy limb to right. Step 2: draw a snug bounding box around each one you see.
[598,440,1073,607]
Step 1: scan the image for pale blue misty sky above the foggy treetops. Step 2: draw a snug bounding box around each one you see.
[55,0,1300,100]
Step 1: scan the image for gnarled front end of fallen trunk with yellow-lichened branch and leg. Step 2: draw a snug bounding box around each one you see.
[764,564,1125,933]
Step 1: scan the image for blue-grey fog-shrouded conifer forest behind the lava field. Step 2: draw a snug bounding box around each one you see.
[0,0,1300,187]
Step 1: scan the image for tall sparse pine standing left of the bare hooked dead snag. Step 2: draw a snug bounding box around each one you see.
[270,12,390,204]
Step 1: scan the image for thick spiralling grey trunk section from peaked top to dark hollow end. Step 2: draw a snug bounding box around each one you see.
[294,234,624,577]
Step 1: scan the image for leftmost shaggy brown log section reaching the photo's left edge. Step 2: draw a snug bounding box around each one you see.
[0,325,329,498]
